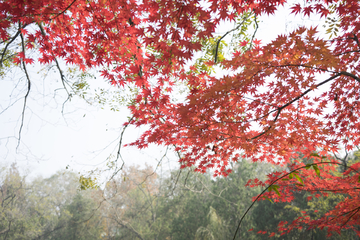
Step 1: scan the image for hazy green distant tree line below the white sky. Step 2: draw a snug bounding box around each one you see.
[0,153,359,240]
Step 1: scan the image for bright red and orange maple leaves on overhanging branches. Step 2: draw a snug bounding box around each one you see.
[0,0,360,236]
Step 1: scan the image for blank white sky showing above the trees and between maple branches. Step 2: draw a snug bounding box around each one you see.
[0,2,324,180]
